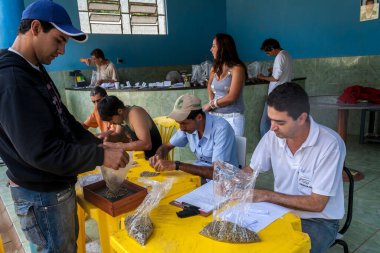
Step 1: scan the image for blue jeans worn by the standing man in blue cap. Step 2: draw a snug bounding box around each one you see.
[10,186,79,253]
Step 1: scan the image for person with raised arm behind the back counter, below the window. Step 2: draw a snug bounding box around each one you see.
[80,48,119,85]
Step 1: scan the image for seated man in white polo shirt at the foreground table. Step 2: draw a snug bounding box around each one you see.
[245,83,346,253]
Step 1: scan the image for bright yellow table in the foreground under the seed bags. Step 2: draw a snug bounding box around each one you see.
[111,194,311,253]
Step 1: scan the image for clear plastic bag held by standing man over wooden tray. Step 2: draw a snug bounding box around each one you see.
[101,154,134,198]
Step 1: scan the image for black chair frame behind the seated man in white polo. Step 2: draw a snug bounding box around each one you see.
[331,166,354,253]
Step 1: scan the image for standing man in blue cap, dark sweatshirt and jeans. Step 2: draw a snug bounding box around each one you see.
[0,0,129,253]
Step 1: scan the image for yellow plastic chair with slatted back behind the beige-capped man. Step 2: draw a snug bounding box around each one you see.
[153,116,179,161]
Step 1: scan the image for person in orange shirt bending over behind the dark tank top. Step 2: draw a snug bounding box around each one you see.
[82,86,122,140]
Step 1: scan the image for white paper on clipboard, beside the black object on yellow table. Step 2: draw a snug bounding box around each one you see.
[175,181,226,213]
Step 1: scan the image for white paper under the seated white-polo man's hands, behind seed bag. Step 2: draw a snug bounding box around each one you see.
[218,202,290,233]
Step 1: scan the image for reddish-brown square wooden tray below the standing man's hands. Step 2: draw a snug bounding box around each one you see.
[83,180,148,217]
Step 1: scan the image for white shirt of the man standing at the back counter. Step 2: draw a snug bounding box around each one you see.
[268,50,294,94]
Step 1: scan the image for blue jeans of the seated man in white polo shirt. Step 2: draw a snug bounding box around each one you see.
[301,219,339,253]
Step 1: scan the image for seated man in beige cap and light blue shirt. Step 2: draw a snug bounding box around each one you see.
[149,94,238,179]
